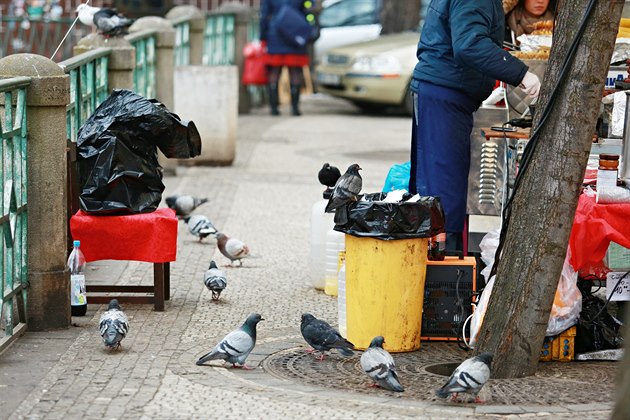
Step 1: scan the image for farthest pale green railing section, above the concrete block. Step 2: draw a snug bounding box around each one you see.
[202,13,236,66]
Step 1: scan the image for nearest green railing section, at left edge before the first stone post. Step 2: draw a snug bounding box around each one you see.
[0,77,31,352]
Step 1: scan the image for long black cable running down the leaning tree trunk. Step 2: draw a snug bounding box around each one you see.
[489,0,597,278]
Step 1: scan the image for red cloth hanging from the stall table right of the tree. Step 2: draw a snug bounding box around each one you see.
[569,194,630,273]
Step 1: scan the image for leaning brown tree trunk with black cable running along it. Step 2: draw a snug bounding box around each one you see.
[477,0,624,378]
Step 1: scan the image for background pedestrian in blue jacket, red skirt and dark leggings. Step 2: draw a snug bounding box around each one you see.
[260,0,315,115]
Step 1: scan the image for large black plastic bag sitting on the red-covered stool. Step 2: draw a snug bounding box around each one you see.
[77,89,201,214]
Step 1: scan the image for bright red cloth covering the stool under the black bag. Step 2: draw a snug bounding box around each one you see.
[70,208,178,263]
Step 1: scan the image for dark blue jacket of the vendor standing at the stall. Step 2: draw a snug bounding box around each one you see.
[411,0,528,104]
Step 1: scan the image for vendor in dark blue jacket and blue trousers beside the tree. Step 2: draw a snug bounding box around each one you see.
[409,0,540,250]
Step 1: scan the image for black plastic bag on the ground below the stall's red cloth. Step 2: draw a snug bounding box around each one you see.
[575,288,623,353]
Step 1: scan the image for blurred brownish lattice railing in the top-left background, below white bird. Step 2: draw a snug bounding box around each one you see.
[0,16,92,62]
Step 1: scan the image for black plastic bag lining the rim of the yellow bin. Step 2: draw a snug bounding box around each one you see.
[334,193,444,240]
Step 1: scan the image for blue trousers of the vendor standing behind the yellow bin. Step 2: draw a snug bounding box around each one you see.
[409,82,479,236]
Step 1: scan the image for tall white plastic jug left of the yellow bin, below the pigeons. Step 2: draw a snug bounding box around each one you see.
[310,191,335,290]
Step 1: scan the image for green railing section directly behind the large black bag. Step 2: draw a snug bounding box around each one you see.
[59,48,111,142]
